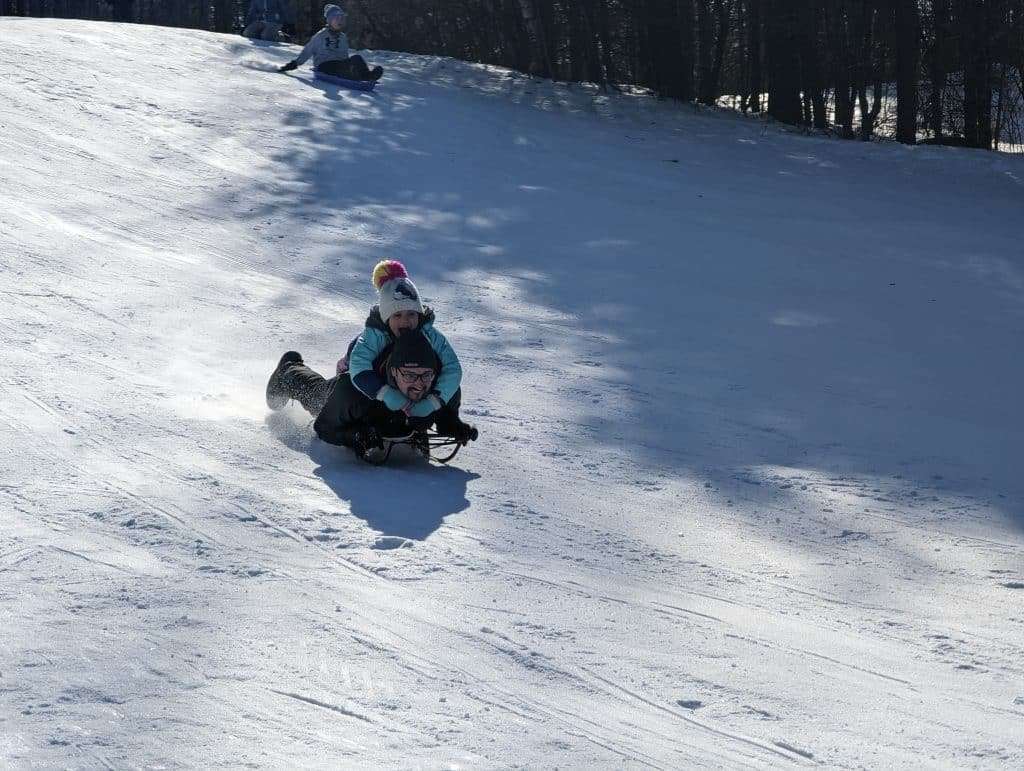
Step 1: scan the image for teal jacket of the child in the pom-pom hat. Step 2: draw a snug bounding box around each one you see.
[348,305,462,417]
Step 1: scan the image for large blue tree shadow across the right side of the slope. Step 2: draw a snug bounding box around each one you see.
[238,49,1024,540]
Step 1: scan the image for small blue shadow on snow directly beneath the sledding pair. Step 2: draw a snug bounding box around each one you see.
[266,413,479,541]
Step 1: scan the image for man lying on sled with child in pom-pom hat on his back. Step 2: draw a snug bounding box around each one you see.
[266,260,477,460]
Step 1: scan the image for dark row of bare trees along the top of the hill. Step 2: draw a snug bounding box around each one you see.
[8,0,1024,148]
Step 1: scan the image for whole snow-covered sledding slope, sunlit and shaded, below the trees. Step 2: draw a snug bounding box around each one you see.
[0,18,1024,768]
